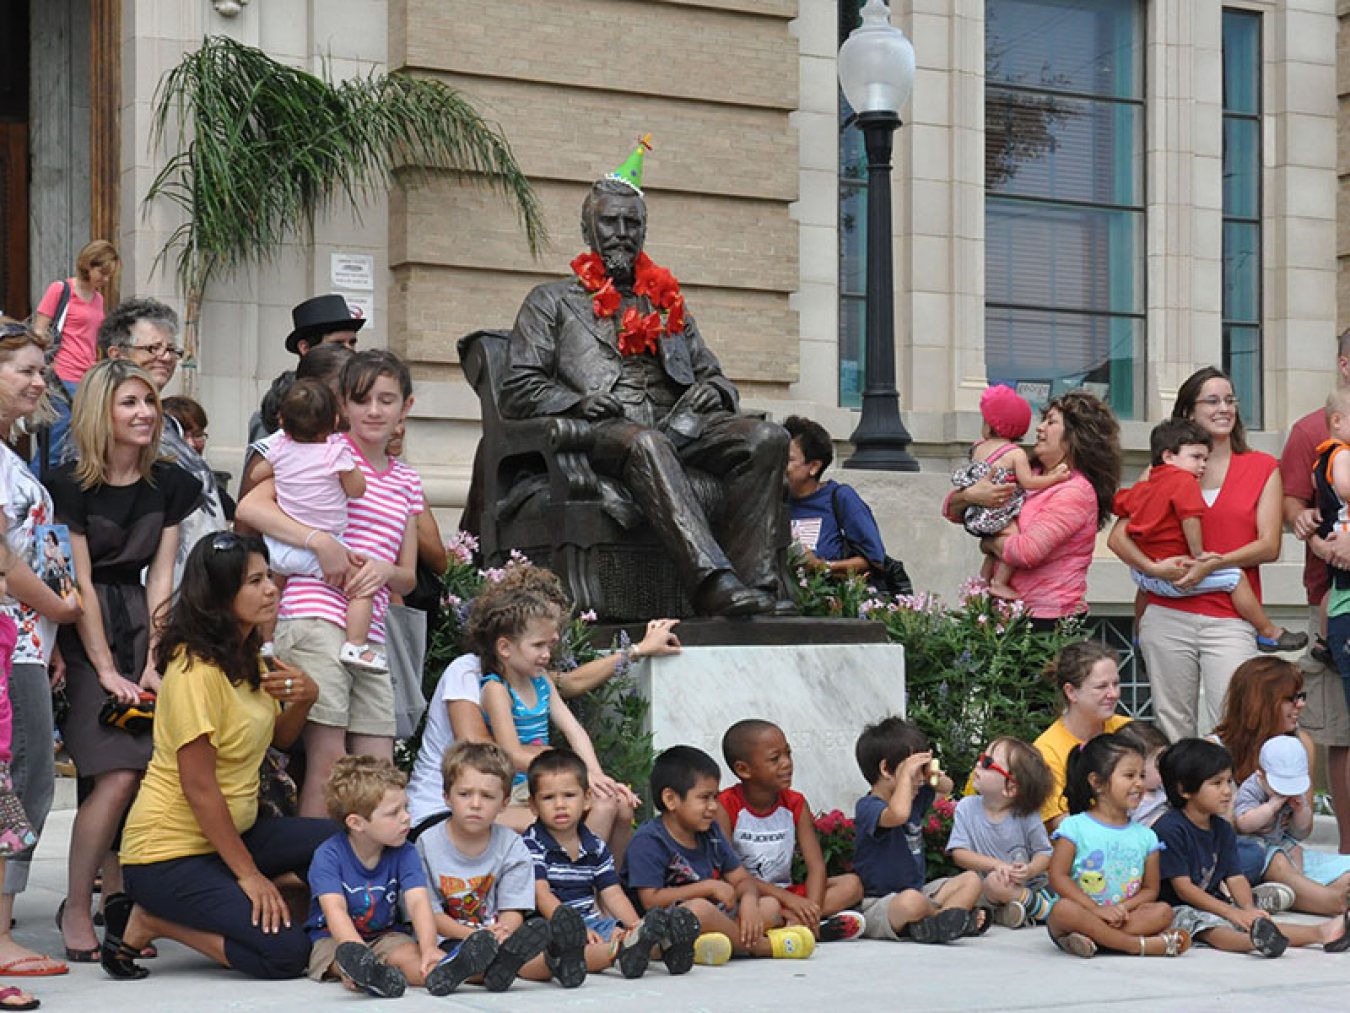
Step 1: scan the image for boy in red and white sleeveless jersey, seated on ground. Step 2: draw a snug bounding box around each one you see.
[717,719,864,941]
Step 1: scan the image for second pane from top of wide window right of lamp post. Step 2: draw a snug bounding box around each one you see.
[984,88,1143,207]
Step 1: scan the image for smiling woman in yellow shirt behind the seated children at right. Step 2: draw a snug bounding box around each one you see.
[1031,640,1130,831]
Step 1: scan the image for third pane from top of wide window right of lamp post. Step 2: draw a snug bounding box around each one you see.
[984,196,1145,313]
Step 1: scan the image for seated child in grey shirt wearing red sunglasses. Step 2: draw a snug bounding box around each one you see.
[946,737,1054,928]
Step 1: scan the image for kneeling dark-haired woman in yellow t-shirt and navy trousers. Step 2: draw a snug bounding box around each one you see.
[101,532,333,978]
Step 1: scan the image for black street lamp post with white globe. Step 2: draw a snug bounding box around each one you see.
[838,0,919,471]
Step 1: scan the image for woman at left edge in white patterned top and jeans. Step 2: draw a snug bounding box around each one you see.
[0,319,80,977]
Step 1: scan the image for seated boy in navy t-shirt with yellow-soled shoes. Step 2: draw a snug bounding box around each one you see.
[624,746,815,974]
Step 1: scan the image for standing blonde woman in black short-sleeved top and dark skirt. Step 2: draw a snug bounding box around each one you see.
[49,359,201,963]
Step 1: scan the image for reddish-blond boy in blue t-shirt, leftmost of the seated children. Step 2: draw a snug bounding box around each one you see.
[305,756,446,998]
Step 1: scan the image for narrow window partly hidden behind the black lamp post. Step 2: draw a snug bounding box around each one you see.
[838,0,867,408]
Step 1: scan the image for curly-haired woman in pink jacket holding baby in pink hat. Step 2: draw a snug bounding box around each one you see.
[942,392,1121,628]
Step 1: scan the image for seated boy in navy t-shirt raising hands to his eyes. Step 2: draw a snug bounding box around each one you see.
[853,717,988,943]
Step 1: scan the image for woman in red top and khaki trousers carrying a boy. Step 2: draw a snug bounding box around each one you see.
[1108,366,1284,742]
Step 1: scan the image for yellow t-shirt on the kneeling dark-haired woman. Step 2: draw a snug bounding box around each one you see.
[120,652,281,866]
